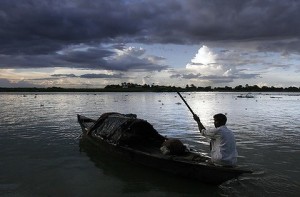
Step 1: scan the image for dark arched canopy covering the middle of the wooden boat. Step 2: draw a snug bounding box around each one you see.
[89,113,166,147]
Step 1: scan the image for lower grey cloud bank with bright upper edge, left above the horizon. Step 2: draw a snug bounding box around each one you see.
[0,45,168,71]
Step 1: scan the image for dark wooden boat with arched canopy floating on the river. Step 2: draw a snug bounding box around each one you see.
[77,113,251,185]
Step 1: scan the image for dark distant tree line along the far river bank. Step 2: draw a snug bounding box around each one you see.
[0,82,300,92]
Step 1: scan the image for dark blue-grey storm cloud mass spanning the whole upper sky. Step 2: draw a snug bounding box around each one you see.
[0,0,300,70]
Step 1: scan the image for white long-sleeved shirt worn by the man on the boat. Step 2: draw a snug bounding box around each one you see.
[201,125,238,166]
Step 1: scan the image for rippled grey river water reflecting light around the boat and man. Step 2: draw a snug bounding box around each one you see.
[0,92,300,197]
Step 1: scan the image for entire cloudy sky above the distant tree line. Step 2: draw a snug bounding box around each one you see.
[0,0,300,88]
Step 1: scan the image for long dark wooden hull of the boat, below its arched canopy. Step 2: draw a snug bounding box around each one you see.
[77,115,251,185]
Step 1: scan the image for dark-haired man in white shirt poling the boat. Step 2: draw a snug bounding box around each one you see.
[194,114,238,166]
